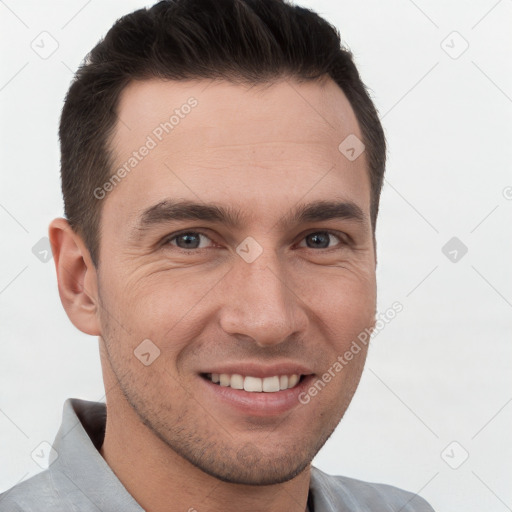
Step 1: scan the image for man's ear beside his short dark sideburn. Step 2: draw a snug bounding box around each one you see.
[48,218,101,336]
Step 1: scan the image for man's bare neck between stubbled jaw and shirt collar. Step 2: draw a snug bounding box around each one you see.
[100,348,310,512]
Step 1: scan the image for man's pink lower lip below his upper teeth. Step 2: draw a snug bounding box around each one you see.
[199,375,314,417]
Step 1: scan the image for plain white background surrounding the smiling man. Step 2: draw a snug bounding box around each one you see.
[0,0,512,512]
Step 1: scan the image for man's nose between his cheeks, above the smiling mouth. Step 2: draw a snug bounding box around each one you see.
[220,256,307,347]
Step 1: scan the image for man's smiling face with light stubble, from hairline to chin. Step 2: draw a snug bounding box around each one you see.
[98,76,376,484]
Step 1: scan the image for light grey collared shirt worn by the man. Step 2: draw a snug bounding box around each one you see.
[0,398,433,512]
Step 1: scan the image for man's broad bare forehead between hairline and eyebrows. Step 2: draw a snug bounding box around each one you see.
[102,79,370,232]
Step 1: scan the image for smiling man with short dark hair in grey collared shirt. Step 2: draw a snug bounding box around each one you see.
[0,0,432,512]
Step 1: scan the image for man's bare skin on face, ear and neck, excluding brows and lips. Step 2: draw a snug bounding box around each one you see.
[49,79,376,512]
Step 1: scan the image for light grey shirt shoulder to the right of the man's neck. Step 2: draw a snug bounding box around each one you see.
[311,467,434,512]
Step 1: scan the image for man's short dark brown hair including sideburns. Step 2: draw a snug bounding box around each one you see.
[59,0,386,267]
